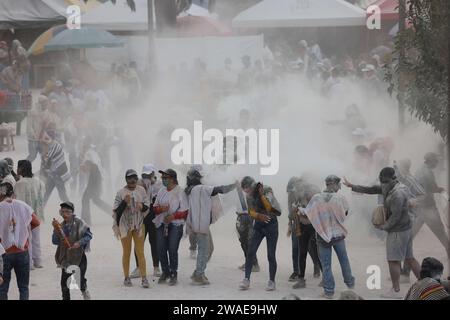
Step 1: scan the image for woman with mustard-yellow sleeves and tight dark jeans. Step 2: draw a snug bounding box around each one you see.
[239,178,281,291]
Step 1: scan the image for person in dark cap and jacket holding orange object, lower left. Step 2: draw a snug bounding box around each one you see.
[52,201,92,300]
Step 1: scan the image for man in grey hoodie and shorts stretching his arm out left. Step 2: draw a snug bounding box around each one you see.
[344,167,420,299]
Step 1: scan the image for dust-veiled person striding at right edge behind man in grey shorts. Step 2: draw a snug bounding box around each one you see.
[413,152,449,255]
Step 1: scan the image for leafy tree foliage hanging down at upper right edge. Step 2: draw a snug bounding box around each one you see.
[386,0,450,139]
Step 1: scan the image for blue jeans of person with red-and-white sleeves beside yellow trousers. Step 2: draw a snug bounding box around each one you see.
[156,223,183,276]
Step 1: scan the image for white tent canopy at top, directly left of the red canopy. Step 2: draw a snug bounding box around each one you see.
[233,0,366,28]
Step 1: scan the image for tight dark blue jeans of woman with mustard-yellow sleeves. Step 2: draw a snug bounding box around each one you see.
[245,217,278,281]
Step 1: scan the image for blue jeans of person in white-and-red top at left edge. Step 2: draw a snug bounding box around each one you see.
[0,251,30,300]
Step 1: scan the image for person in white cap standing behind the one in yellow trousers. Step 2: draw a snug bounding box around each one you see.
[130,163,163,279]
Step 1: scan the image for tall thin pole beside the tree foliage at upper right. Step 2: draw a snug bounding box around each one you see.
[398,0,406,133]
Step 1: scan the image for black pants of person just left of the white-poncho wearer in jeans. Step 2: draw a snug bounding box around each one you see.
[298,223,322,278]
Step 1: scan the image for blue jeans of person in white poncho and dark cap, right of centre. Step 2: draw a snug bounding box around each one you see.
[317,236,355,294]
